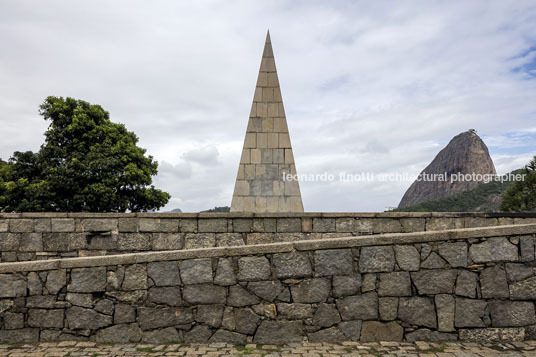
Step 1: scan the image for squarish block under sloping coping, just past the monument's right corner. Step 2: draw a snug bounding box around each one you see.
[314,249,354,276]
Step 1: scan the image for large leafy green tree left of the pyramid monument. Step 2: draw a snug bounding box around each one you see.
[0,97,170,212]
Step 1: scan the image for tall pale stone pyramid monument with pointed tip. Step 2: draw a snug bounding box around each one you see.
[231,32,303,213]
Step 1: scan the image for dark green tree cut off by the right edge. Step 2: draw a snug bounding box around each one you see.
[501,156,536,212]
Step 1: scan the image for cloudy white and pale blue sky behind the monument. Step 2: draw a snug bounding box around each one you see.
[0,0,536,212]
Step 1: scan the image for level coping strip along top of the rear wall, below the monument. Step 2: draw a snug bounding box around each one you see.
[0,212,536,219]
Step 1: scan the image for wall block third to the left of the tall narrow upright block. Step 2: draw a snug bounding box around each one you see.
[337,292,378,321]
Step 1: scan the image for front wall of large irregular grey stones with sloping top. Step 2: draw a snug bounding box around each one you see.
[0,220,536,344]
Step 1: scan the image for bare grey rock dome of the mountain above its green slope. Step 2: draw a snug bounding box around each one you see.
[398,129,496,208]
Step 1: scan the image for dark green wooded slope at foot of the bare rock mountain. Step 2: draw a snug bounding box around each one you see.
[394,170,519,212]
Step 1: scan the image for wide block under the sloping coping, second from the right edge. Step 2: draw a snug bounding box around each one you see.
[469,237,518,263]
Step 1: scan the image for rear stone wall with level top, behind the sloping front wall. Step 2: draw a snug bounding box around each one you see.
[0,213,536,262]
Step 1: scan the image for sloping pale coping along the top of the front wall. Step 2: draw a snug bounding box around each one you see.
[0,224,536,273]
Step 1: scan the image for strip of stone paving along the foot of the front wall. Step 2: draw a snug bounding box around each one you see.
[0,341,536,357]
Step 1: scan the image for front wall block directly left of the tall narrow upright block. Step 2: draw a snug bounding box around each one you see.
[398,296,437,328]
